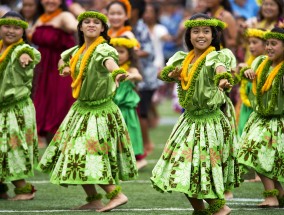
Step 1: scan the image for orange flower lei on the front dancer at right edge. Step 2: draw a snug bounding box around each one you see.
[252,57,284,95]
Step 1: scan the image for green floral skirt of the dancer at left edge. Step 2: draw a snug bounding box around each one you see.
[0,98,38,181]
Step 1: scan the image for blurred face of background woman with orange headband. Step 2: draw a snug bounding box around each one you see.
[107,3,128,28]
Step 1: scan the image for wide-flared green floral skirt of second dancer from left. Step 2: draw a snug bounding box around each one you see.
[38,101,137,185]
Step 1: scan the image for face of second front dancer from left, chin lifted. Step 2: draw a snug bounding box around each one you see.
[80,18,104,39]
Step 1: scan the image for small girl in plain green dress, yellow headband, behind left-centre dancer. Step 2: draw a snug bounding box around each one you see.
[110,37,144,169]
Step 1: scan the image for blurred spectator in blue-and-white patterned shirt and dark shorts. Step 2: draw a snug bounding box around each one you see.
[130,0,158,168]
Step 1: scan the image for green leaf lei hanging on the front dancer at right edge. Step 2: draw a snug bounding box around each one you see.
[256,61,284,116]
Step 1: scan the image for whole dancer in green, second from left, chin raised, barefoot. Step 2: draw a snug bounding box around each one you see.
[39,11,137,212]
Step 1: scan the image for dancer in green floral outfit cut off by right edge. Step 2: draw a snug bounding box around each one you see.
[238,27,284,207]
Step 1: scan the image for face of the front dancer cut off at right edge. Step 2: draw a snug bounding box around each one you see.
[265,38,284,62]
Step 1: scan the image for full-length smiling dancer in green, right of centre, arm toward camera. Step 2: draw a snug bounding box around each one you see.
[151,14,240,214]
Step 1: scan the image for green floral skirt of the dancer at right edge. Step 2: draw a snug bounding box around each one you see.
[238,112,284,182]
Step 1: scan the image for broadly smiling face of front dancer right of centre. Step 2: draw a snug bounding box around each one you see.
[190,26,213,51]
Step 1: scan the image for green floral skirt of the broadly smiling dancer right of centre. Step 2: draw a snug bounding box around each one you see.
[151,110,240,199]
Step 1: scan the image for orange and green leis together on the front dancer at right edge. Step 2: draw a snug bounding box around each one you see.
[253,58,284,116]
